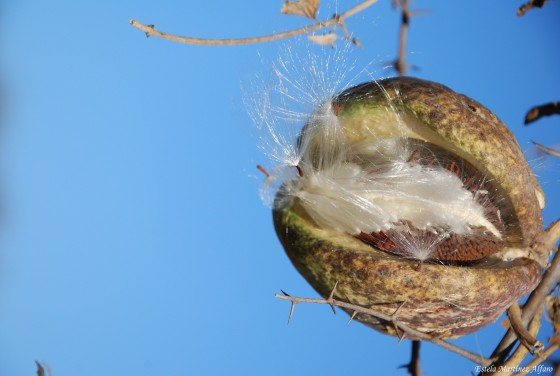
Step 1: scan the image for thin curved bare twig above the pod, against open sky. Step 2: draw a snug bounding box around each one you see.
[130,0,378,46]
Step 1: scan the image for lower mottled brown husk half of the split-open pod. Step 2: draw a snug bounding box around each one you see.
[274,203,541,338]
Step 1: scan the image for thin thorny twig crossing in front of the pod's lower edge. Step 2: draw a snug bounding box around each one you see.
[274,294,492,366]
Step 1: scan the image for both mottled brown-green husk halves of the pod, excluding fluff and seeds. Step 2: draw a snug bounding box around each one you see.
[273,77,544,338]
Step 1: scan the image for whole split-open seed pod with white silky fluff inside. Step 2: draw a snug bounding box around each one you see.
[273,78,544,338]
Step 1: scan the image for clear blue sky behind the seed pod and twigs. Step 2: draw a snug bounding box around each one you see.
[0,0,560,376]
